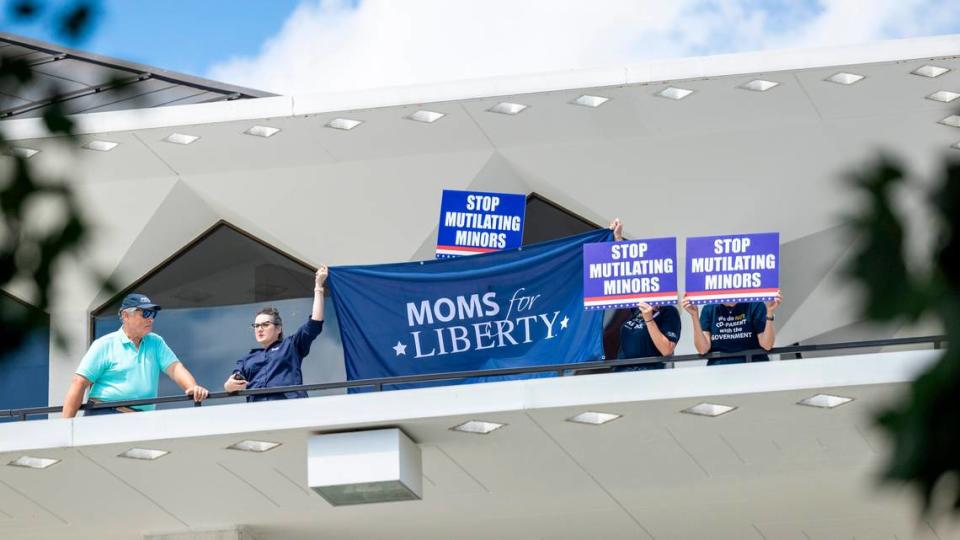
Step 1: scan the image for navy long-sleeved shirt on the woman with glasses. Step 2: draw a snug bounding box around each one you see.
[233,319,323,401]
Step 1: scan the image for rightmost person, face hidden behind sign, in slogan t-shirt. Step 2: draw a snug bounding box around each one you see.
[682,292,783,366]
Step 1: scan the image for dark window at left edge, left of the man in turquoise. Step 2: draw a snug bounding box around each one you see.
[0,291,50,422]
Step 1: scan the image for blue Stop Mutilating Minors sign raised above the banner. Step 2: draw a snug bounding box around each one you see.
[437,189,527,259]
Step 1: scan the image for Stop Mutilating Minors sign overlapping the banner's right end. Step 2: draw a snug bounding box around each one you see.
[583,238,677,309]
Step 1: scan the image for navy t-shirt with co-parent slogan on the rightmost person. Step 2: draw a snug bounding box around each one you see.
[700,302,770,366]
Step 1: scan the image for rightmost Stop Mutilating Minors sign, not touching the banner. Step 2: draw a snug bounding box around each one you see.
[686,233,780,304]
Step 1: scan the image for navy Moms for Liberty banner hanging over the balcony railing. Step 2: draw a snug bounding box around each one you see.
[328,229,612,386]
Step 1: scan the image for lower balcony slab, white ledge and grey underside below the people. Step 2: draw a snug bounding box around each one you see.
[0,351,947,539]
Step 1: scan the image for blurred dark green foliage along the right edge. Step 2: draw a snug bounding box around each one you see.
[847,155,960,511]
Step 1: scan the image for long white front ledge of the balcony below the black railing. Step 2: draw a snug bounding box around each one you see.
[0,350,940,452]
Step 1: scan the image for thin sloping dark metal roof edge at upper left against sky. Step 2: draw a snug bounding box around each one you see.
[0,32,278,98]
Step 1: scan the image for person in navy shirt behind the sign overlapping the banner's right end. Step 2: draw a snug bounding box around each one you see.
[610,218,681,371]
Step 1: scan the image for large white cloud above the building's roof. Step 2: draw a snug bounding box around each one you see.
[208,0,960,94]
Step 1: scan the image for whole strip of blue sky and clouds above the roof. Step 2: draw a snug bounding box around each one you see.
[0,0,960,94]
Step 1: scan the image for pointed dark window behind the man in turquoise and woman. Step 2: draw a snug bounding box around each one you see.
[93,223,344,406]
